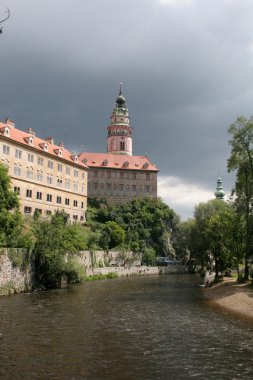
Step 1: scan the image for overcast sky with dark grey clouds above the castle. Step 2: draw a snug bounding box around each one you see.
[0,0,253,219]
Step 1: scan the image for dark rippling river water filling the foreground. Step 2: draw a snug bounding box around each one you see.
[0,275,253,380]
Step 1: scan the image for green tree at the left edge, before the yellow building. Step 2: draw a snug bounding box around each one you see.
[0,164,23,247]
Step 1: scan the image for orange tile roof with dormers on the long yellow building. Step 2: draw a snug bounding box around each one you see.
[0,122,88,169]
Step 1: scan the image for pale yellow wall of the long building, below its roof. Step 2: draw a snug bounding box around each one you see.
[0,136,87,221]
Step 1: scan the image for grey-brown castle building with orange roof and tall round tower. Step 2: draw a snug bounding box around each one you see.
[79,86,159,204]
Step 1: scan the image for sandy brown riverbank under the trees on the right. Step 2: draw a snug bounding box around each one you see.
[203,278,253,322]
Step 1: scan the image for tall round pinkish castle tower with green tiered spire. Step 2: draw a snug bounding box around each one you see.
[107,83,133,156]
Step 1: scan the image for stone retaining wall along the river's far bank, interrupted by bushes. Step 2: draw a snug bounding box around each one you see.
[0,248,185,295]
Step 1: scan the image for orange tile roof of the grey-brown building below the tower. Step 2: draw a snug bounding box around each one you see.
[79,152,159,172]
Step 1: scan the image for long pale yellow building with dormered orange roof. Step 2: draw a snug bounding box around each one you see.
[0,119,88,221]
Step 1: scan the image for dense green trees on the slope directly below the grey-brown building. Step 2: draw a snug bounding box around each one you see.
[88,198,179,256]
